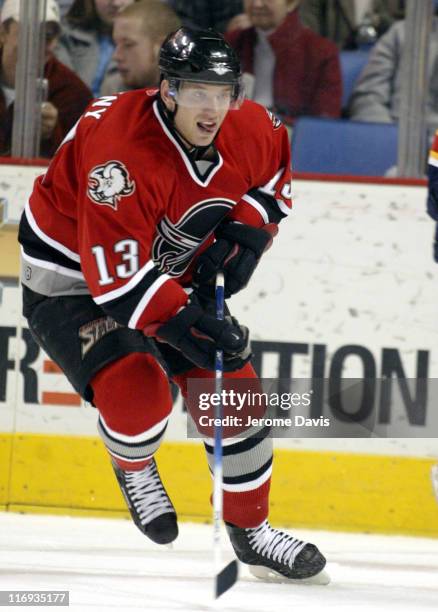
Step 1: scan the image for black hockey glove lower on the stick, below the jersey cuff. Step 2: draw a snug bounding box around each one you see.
[155,296,251,372]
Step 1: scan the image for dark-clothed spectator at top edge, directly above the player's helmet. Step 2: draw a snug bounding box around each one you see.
[165,0,243,32]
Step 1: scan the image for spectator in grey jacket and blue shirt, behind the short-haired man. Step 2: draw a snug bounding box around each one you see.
[56,0,134,97]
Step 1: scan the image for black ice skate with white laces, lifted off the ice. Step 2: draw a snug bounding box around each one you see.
[113,459,178,544]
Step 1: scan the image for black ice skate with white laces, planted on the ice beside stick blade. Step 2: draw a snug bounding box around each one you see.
[226,521,330,584]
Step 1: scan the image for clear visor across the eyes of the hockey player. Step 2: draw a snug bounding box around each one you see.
[169,79,245,110]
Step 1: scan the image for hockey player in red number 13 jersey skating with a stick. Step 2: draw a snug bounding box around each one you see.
[19,28,325,579]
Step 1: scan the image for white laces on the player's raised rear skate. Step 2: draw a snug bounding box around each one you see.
[125,460,175,525]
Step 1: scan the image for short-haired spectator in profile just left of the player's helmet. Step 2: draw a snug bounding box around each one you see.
[102,0,181,95]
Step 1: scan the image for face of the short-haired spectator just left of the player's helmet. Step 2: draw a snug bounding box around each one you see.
[113,16,159,89]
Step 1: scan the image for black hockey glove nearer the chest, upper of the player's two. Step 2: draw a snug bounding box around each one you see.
[193,221,272,298]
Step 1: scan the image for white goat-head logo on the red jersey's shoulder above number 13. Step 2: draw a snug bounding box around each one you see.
[87,160,135,210]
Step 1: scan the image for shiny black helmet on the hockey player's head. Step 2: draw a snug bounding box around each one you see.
[158,27,244,106]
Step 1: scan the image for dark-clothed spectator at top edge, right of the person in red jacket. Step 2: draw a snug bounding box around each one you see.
[300,0,405,49]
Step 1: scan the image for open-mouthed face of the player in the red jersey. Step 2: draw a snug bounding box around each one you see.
[162,81,232,147]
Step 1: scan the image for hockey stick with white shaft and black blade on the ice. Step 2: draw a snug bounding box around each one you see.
[213,272,238,599]
